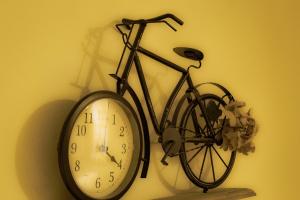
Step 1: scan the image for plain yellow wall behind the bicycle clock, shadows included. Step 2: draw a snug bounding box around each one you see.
[0,0,300,200]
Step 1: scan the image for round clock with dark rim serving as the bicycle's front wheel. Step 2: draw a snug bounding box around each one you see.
[58,91,142,200]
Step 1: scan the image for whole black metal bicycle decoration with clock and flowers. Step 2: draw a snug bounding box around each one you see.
[58,14,256,200]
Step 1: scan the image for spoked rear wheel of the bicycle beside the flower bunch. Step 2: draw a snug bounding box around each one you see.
[180,94,236,190]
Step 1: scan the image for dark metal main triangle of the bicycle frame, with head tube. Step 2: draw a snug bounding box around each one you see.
[117,23,202,135]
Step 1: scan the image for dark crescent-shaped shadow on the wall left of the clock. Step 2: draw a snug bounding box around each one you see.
[15,100,75,200]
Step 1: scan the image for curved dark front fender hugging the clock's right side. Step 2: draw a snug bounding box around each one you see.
[110,74,150,178]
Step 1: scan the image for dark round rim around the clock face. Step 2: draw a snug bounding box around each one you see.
[58,91,143,200]
